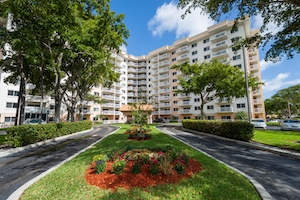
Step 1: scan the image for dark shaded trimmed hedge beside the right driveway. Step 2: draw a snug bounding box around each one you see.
[182,120,254,141]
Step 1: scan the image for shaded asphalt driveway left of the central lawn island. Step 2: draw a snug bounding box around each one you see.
[0,125,117,200]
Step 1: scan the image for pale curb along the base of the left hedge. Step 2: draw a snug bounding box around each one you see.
[0,128,94,158]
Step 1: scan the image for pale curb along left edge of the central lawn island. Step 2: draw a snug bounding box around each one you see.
[7,127,120,200]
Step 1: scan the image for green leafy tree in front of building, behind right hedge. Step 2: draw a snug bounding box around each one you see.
[172,59,262,119]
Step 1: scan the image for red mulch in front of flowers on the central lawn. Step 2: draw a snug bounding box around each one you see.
[85,159,202,191]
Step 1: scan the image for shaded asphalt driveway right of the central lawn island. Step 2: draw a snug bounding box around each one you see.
[159,127,300,200]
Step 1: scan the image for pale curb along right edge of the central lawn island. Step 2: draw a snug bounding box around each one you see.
[155,126,274,200]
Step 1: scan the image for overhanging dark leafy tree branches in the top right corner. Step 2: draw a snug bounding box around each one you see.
[178,0,300,61]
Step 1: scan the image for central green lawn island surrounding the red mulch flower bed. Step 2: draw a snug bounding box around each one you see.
[21,125,260,200]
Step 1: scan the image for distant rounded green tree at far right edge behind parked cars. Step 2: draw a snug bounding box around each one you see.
[265,84,300,118]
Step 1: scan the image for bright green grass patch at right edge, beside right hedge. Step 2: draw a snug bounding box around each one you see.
[252,130,300,152]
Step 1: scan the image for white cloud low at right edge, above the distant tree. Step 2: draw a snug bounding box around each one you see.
[263,73,300,93]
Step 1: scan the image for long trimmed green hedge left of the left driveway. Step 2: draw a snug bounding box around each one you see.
[3,120,92,147]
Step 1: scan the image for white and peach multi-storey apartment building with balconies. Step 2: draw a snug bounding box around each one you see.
[0,18,265,126]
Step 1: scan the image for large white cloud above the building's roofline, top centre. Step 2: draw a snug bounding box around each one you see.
[148,1,214,39]
